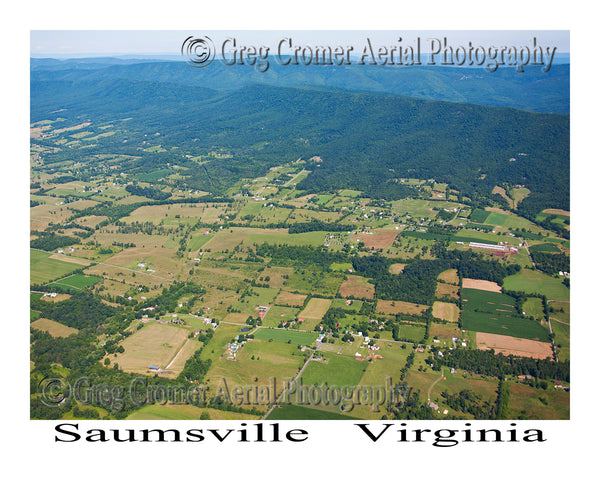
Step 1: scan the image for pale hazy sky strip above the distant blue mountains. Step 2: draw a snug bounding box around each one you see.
[30,30,570,57]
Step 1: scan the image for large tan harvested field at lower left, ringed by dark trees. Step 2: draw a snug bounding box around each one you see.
[110,322,200,376]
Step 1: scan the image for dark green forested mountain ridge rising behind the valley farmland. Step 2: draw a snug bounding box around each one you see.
[31,79,569,214]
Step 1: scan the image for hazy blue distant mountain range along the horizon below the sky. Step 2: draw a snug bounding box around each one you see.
[31,57,570,114]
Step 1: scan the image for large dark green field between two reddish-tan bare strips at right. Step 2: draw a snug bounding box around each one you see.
[461,288,549,342]
